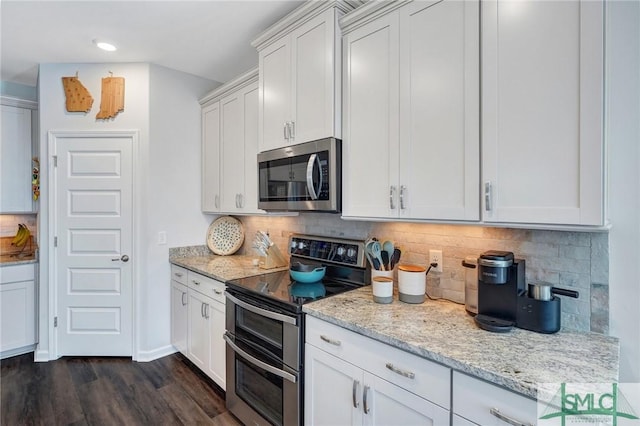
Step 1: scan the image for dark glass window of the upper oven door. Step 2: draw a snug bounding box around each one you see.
[236,306,283,359]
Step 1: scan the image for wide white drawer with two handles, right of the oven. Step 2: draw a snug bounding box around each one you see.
[306,315,451,409]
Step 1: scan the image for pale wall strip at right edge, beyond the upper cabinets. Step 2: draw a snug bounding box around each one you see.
[605,1,640,382]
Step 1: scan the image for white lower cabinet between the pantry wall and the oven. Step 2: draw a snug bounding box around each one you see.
[171,265,226,389]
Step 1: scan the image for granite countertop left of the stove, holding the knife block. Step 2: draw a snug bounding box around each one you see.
[169,246,289,281]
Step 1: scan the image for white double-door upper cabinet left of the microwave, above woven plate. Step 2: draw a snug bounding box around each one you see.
[200,70,264,214]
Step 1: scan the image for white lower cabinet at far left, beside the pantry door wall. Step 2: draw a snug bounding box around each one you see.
[0,263,36,358]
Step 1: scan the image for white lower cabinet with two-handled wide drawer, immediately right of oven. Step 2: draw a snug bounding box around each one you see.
[305,316,451,425]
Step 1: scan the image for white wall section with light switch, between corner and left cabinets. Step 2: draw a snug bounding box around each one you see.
[140,65,219,359]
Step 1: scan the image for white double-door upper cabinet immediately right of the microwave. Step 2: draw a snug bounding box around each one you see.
[341,0,480,220]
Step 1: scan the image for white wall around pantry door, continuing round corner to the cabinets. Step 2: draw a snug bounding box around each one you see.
[36,64,218,360]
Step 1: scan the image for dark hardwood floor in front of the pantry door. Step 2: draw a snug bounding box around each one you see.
[0,353,240,426]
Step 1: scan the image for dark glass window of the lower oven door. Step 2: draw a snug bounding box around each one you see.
[234,356,284,425]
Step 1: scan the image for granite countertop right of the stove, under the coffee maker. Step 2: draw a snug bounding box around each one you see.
[303,286,619,399]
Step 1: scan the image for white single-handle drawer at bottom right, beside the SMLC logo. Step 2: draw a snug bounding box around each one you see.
[453,371,537,425]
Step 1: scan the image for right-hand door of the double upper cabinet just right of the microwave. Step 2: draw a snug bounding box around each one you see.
[399,0,480,220]
